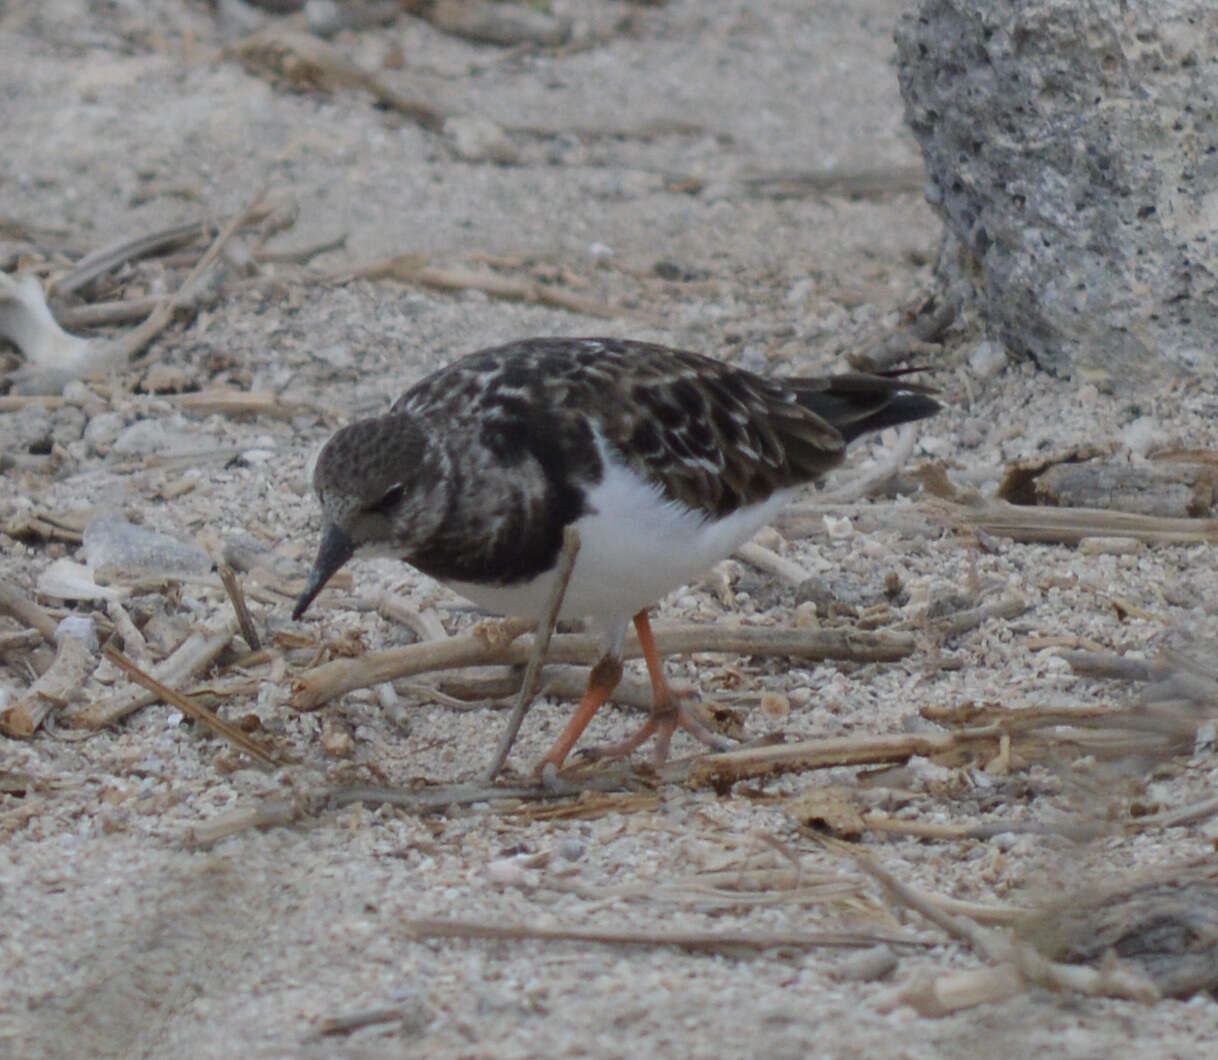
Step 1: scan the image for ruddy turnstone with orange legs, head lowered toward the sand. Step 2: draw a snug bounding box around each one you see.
[292,339,939,771]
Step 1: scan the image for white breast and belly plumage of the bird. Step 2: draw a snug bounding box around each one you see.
[446,445,792,634]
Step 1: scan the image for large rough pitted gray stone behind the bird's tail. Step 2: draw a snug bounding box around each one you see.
[896,0,1218,385]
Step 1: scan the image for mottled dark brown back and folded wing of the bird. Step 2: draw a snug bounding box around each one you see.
[393,339,937,515]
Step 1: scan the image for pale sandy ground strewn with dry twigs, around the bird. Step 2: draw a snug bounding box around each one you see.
[7,0,1218,1058]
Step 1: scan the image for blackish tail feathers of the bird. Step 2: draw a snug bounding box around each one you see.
[787,372,940,442]
